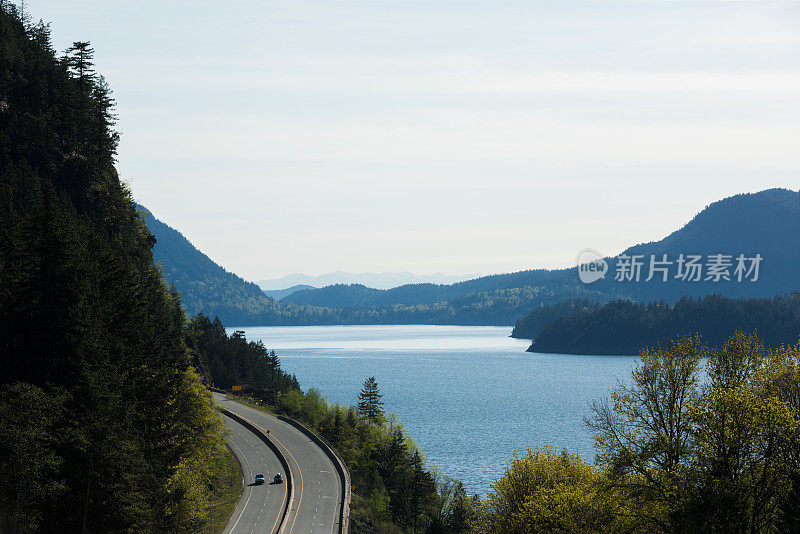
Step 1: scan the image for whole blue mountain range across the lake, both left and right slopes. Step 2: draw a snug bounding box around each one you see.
[141,189,800,325]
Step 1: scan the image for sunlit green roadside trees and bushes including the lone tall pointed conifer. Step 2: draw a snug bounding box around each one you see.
[253,379,478,534]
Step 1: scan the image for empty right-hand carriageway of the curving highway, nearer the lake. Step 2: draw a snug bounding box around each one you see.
[214,393,342,534]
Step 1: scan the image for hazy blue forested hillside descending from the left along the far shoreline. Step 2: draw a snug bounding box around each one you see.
[139,206,621,326]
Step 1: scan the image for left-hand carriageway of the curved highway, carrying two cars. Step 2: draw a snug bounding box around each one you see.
[222,415,287,534]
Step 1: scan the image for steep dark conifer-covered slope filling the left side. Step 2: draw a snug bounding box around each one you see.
[0,6,227,533]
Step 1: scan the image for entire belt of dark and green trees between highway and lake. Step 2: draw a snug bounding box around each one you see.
[186,320,477,534]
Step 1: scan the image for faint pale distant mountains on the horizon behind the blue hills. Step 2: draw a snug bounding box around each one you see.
[256,271,479,292]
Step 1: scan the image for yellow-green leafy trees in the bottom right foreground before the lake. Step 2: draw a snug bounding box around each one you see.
[473,332,800,534]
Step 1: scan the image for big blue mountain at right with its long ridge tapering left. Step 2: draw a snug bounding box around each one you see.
[284,189,800,309]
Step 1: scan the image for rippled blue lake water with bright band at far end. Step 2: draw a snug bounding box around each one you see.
[228,325,635,496]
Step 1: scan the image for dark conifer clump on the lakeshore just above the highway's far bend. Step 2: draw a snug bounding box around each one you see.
[186,314,300,391]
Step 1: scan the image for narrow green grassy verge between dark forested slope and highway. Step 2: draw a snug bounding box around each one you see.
[199,447,243,534]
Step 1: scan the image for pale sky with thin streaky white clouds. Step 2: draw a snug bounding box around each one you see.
[25,0,800,280]
